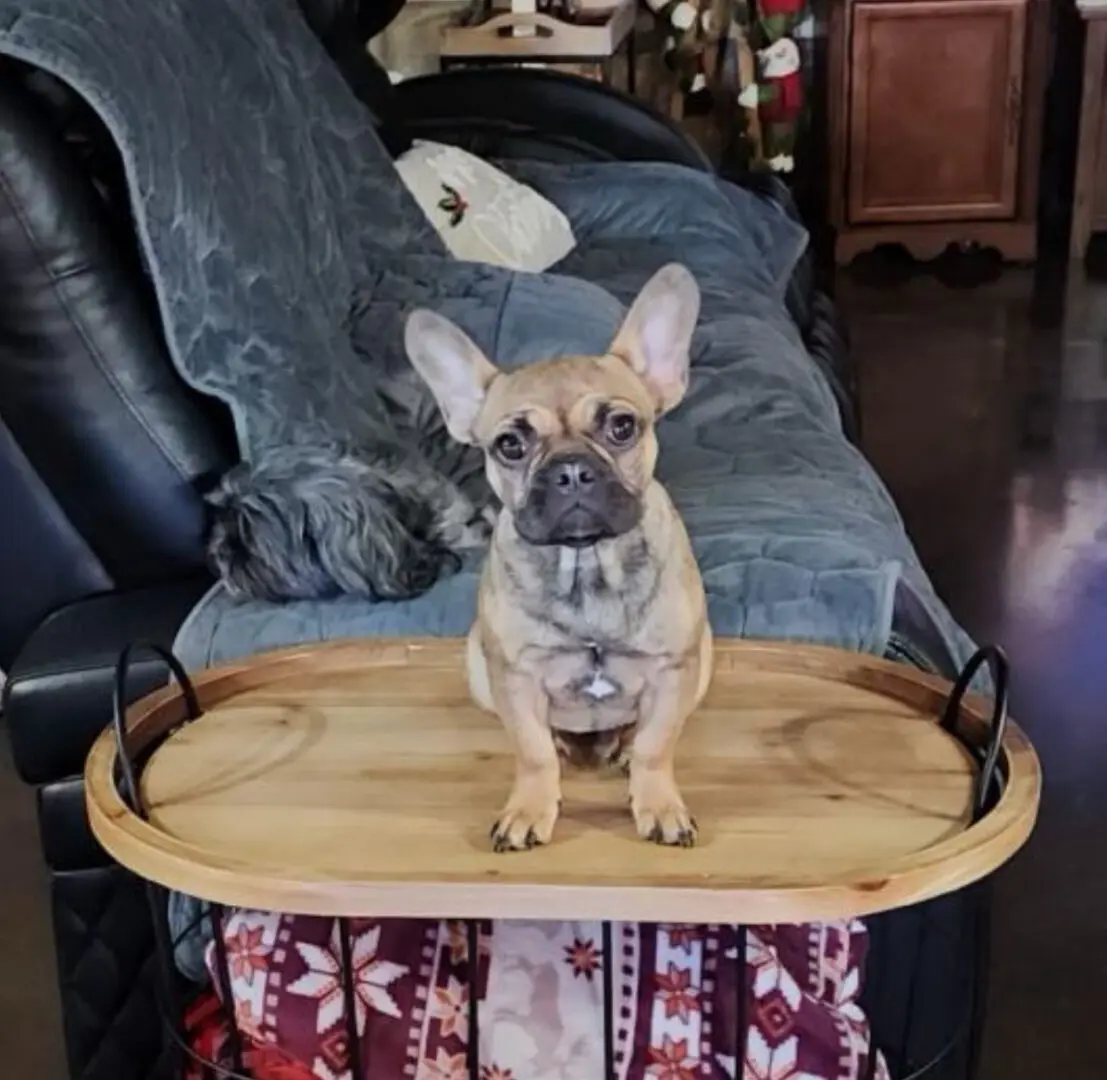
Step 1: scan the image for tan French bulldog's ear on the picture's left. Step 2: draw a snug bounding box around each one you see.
[404,308,498,444]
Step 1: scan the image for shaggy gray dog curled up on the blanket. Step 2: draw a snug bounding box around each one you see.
[207,325,494,601]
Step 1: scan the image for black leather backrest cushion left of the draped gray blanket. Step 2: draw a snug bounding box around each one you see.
[0,73,235,584]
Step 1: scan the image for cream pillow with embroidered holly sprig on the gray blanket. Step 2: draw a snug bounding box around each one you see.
[395,141,577,271]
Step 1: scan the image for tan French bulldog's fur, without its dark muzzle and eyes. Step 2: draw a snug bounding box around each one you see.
[406,266,712,850]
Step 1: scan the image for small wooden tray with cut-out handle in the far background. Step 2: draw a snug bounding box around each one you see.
[439,0,638,60]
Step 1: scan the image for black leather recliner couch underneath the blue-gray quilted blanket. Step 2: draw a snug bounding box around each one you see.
[0,0,850,1080]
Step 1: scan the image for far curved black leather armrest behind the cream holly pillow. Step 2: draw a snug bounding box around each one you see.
[390,68,712,172]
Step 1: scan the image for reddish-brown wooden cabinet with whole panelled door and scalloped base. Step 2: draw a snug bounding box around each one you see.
[829,0,1045,262]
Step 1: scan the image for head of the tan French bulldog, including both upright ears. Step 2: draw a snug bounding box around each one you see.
[405,263,700,548]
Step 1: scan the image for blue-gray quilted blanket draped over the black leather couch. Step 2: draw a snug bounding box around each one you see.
[0,0,968,664]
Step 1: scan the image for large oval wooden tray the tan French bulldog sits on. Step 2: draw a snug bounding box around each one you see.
[85,640,1041,923]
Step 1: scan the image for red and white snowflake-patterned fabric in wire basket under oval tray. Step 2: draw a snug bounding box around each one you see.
[183,911,888,1080]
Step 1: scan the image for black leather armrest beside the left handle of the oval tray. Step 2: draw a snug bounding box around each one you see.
[3,578,210,783]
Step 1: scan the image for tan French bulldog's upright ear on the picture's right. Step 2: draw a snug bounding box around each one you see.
[609,262,700,415]
